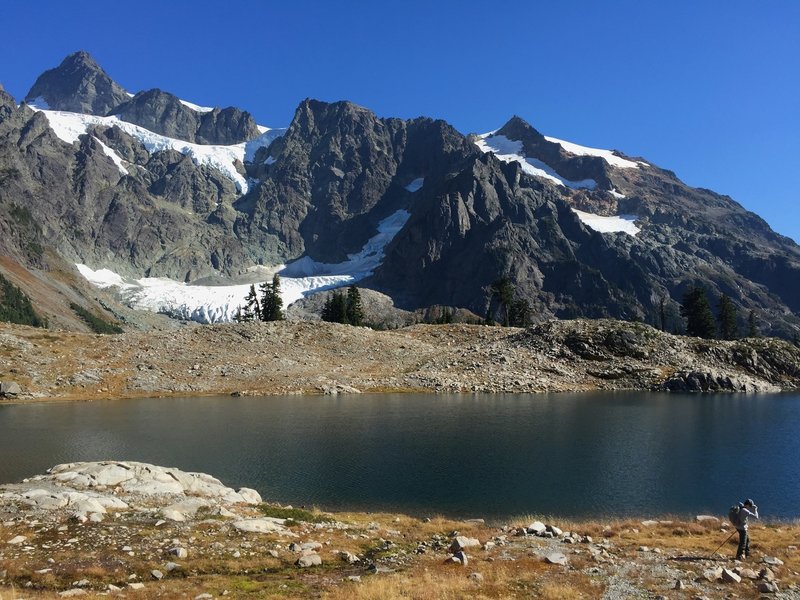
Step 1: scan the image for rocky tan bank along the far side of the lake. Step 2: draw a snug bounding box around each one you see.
[0,320,800,402]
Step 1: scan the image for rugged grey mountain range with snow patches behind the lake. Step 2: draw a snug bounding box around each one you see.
[0,52,800,337]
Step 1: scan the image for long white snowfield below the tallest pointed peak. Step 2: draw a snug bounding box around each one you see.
[36,107,286,194]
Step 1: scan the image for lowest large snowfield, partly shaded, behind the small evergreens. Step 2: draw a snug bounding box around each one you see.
[77,210,410,323]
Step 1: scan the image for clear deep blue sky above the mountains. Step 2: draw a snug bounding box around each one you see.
[0,0,800,240]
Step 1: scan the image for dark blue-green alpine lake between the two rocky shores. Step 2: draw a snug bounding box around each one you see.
[0,393,800,518]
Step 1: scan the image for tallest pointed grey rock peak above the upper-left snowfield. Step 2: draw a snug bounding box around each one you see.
[25,50,128,115]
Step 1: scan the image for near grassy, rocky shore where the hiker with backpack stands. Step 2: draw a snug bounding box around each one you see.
[0,461,800,600]
